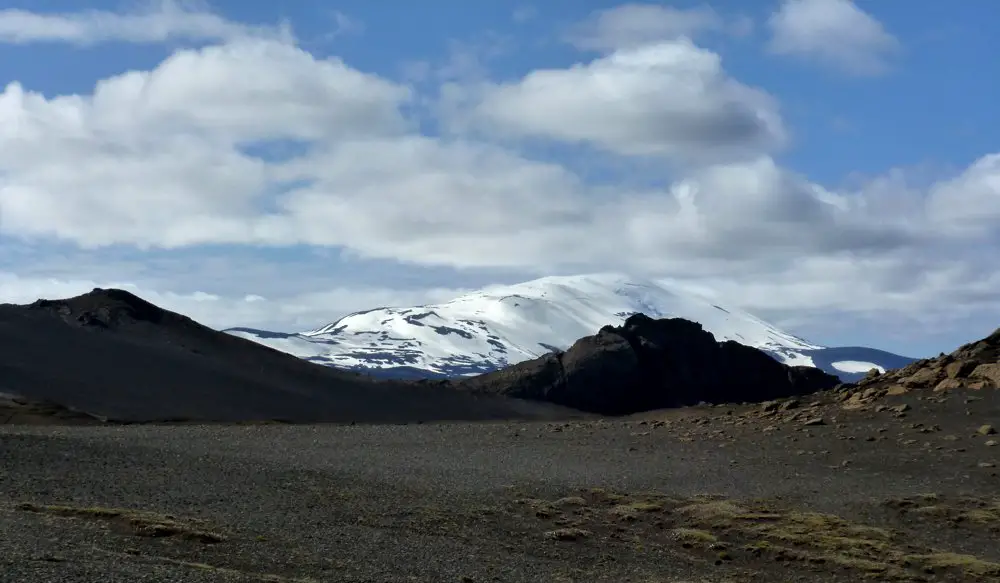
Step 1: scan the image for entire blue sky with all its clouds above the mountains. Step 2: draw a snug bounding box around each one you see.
[0,0,1000,356]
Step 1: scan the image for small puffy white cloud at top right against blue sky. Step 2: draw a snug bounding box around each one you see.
[768,0,900,75]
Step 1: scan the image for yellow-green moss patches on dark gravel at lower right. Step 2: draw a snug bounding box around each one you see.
[504,489,1000,581]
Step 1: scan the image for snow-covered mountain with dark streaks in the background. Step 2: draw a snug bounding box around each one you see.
[227,274,912,380]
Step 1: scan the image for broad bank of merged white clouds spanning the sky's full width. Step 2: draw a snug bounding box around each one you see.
[0,3,1000,352]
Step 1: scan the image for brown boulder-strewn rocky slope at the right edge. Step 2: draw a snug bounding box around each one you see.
[844,329,1000,409]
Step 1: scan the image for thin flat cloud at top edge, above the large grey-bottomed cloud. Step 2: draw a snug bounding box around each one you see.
[565,4,752,51]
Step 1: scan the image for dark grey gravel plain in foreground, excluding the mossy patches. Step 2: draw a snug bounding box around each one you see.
[0,395,1000,583]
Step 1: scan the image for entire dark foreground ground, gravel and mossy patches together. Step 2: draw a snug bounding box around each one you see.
[0,391,1000,583]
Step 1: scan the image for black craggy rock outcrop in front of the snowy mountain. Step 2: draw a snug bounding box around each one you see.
[457,314,839,415]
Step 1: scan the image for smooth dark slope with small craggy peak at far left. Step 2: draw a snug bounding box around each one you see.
[0,289,584,423]
